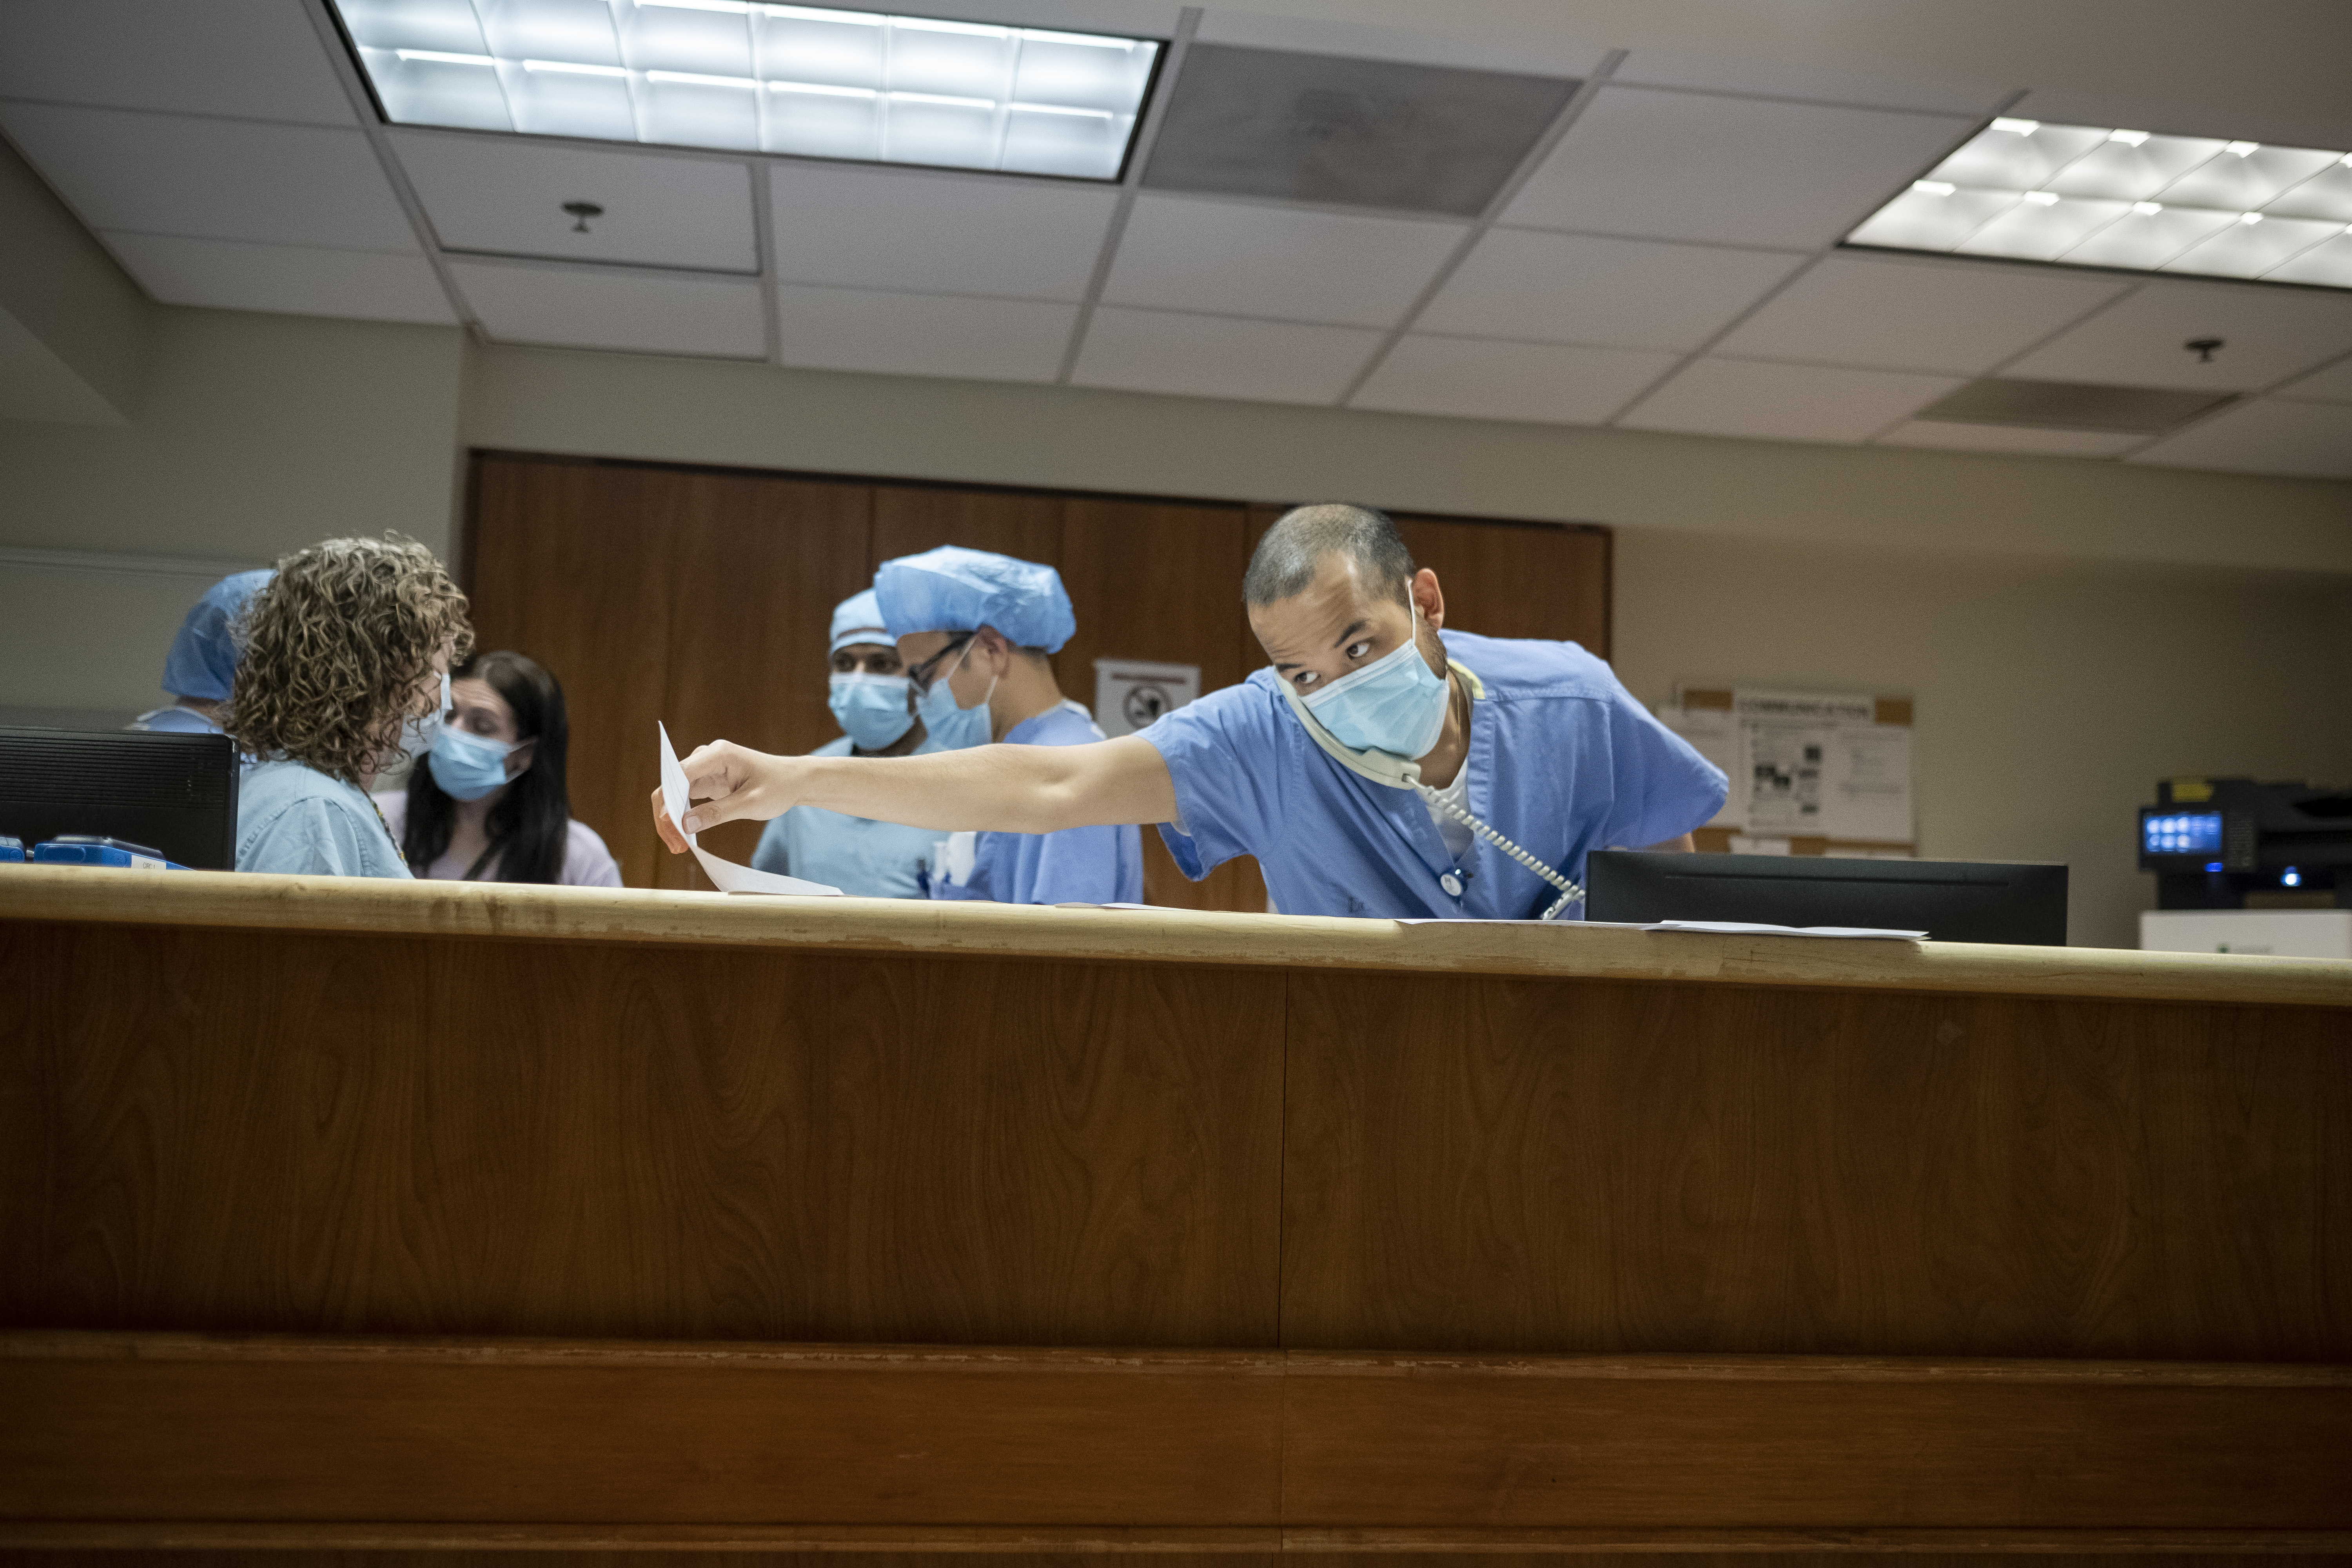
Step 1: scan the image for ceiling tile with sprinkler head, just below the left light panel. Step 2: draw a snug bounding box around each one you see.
[390,132,760,273]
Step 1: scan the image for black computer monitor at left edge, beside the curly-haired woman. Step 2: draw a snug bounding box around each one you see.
[0,726,238,872]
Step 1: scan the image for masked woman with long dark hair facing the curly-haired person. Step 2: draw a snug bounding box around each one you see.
[376,653,621,886]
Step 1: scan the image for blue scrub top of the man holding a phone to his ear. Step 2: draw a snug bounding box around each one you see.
[1141,632,1726,919]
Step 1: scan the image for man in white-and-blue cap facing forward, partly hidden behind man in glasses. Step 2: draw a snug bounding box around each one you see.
[750,588,938,898]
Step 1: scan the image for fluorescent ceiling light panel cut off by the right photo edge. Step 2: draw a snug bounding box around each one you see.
[1846,118,2352,289]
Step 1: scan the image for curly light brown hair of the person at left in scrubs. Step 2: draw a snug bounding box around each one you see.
[221,534,473,785]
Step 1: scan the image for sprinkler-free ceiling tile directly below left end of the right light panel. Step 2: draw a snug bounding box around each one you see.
[1715,256,2133,376]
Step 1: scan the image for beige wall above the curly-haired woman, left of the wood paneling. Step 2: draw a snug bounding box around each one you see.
[0,310,463,712]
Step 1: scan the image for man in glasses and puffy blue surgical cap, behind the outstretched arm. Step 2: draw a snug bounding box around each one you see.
[875,545,1143,903]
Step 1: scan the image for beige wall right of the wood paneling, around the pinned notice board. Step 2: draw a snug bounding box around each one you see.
[1616,529,2352,947]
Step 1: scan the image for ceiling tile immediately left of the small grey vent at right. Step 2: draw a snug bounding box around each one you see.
[1618,360,1959,442]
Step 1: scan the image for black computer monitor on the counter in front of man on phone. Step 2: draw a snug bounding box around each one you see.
[1585,849,2065,947]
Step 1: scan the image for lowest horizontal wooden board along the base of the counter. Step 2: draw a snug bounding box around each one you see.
[0,1335,2352,1561]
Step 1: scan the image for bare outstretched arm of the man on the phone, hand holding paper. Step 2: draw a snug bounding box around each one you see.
[654,736,1176,853]
